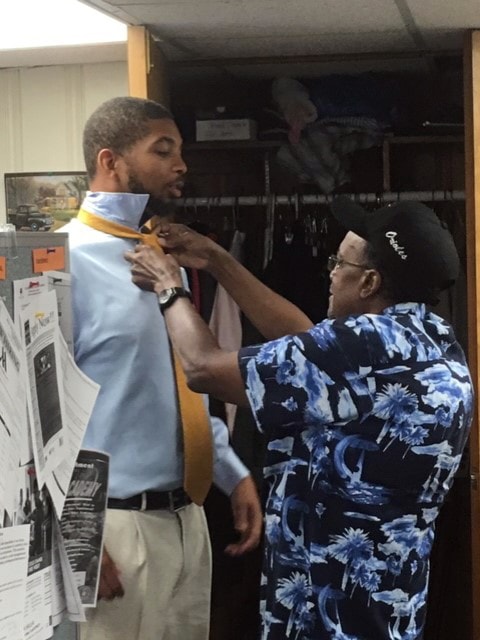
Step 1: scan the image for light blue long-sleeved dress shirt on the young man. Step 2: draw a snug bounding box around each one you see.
[61,193,248,498]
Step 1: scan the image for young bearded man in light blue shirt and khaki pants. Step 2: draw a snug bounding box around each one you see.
[62,98,262,640]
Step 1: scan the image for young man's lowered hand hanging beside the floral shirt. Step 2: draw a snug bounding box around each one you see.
[225,476,263,556]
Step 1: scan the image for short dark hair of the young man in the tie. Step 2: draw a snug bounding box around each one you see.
[83,96,173,180]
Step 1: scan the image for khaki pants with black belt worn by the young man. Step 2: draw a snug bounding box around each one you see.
[79,504,211,640]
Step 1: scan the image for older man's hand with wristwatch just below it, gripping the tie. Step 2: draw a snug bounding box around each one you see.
[125,244,183,293]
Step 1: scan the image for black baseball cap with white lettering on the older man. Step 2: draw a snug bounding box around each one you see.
[331,196,460,302]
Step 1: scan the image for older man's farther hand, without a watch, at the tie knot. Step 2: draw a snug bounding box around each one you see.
[152,222,219,270]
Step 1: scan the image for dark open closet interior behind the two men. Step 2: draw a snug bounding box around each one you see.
[158,55,472,640]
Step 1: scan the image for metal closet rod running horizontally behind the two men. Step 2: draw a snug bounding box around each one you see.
[177,190,465,207]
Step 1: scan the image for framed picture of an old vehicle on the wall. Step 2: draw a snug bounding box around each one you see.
[5,171,88,231]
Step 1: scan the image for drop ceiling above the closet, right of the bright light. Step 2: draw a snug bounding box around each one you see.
[84,0,472,59]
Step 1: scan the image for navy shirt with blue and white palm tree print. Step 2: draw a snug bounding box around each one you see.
[239,304,473,640]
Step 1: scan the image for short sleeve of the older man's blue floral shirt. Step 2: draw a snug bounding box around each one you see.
[239,320,371,429]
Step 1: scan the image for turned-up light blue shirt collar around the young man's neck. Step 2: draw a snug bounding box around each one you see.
[82,191,150,230]
